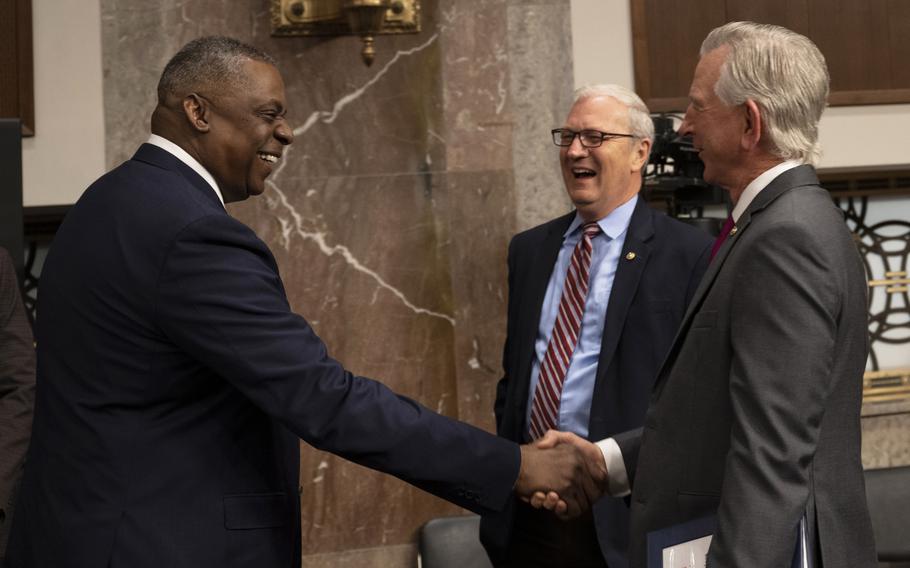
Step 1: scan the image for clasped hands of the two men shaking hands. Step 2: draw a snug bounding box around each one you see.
[515,430,607,519]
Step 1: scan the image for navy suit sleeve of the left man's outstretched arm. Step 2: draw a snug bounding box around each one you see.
[156,215,520,513]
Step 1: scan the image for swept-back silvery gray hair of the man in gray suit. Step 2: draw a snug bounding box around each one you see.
[701,22,830,165]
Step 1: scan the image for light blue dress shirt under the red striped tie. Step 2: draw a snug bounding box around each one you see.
[525,195,638,438]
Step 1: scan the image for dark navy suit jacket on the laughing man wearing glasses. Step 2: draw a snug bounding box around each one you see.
[481,199,712,568]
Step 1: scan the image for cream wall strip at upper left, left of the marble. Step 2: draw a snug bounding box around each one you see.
[22,0,104,206]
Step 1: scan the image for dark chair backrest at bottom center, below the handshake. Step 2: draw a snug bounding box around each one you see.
[417,515,493,568]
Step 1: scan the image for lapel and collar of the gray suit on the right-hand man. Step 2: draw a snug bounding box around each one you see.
[653,166,818,396]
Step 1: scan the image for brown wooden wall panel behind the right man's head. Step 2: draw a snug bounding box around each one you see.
[630,0,910,111]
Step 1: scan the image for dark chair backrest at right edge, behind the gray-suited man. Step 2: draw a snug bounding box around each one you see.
[865,466,910,562]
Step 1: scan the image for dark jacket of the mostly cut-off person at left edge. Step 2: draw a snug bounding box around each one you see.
[0,248,35,560]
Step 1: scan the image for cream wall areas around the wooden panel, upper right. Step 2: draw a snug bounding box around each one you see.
[572,0,910,168]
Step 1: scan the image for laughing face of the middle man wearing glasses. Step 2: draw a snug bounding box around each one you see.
[559,96,651,221]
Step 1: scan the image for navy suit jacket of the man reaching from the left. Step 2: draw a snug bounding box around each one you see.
[8,145,520,568]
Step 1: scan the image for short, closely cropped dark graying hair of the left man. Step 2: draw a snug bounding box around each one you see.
[158,36,277,104]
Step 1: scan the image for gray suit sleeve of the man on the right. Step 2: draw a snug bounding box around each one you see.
[709,222,843,566]
